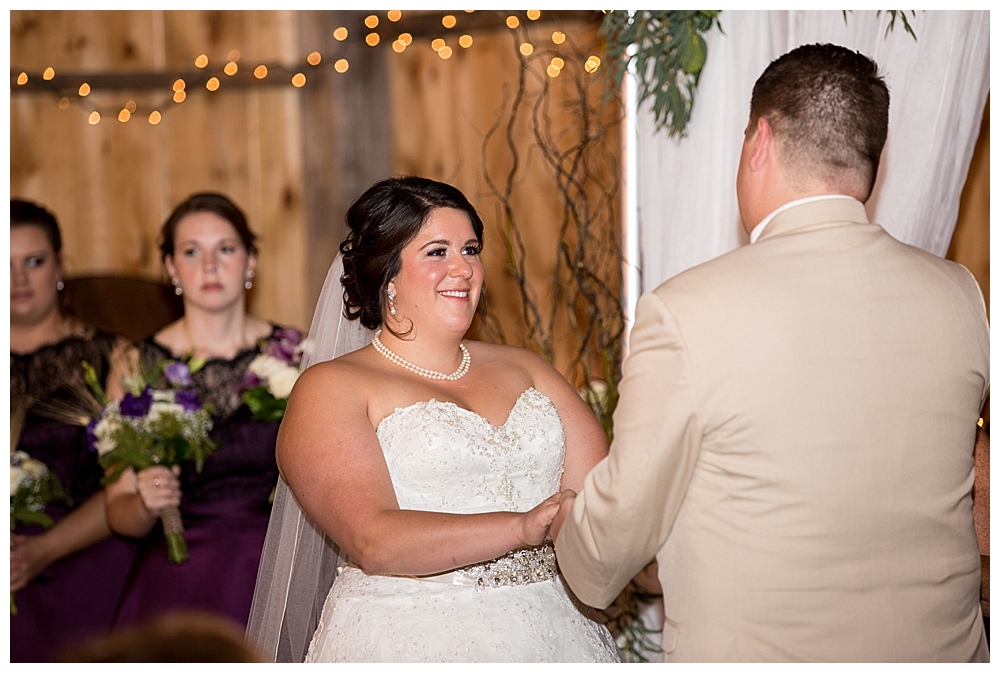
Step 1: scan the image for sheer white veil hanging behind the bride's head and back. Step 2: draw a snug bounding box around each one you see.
[246,254,372,662]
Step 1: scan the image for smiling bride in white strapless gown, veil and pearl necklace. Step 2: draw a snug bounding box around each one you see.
[248,177,618,662]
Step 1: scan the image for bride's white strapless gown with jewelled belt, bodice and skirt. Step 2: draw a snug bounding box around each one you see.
[306,388,619,662]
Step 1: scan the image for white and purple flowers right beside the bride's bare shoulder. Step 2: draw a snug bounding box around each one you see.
[242,328,306,421]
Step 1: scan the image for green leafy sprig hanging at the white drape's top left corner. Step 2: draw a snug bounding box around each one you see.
[599,9,722,136]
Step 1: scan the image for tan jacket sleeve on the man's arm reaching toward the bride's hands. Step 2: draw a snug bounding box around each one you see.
[555,293,701,608]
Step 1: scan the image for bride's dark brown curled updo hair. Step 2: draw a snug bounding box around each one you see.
[340,175,483,330]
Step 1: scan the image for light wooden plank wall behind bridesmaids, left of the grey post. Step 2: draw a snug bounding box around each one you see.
[10,11,313,334]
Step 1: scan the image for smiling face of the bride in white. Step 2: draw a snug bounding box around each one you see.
[387,208,483,336]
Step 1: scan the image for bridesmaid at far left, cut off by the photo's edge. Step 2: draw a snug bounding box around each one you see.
[10,200,134,662]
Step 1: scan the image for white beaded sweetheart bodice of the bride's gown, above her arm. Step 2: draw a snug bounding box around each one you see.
[377,388,566,514]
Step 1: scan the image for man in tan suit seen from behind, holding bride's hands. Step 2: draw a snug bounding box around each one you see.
[552,45,989,661]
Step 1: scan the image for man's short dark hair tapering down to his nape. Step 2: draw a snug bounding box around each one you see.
[749,44,889,201]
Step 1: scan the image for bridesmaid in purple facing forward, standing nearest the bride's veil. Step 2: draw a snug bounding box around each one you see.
[105,193,297,628]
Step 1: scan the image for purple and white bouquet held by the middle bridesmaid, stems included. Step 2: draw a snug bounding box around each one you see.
[84,359,217,564]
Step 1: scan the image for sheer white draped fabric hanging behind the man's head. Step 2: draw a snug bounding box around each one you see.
[629,10,990,288]
